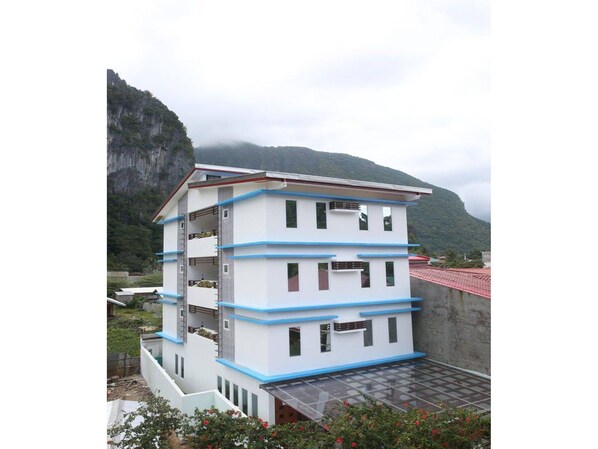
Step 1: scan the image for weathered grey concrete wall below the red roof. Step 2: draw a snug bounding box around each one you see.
[411,277,490,375]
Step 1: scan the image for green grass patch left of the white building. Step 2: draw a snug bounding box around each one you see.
[107,308,162,357]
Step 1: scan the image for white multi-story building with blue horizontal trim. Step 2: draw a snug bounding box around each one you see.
[142,164,432,423]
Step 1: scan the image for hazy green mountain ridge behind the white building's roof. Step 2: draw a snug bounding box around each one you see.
[195,142,490,253]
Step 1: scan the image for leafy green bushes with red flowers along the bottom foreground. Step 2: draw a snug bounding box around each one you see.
[110,398,490,449]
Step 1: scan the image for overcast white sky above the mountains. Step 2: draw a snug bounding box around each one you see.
[106,0,490,221]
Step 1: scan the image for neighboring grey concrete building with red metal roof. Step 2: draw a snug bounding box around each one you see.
[409,265,491,376]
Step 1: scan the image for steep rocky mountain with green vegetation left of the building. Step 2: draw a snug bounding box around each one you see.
[106,70,194,271]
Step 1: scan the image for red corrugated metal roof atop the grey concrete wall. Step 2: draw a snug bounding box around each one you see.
[409,265,490,299]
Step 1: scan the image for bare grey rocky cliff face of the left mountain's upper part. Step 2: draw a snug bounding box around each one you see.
[107,70,195,194]
